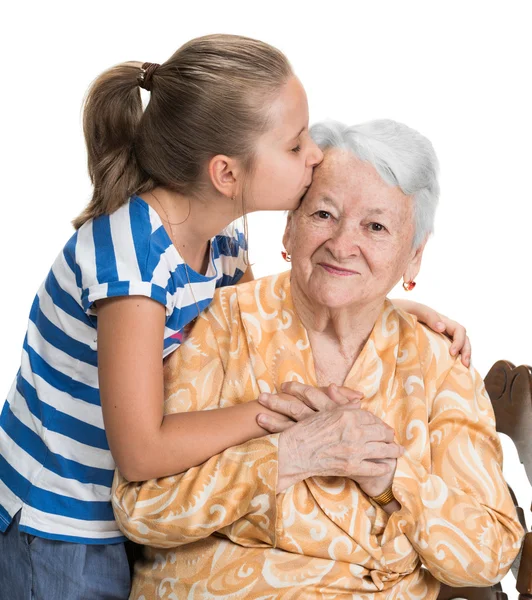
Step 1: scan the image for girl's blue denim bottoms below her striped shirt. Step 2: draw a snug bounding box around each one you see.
[0,512,131,600]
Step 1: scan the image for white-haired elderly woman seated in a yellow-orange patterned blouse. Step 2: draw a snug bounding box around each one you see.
[114,121,522,600]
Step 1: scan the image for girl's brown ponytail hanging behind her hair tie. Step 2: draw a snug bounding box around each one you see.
[72,62,149,229]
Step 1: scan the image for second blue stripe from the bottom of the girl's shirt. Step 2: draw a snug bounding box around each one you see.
[0,402,114,488]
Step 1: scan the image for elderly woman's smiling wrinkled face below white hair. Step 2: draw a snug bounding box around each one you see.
[284,149,422,308]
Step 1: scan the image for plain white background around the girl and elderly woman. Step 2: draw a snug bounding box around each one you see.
[0,0,532,598]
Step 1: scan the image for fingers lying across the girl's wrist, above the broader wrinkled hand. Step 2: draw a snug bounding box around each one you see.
[257,381,363,433]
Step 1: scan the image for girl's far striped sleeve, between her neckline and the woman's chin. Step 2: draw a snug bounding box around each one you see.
[215,219,248,287]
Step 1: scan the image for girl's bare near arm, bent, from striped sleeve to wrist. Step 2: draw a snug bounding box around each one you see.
[98,296,280,481]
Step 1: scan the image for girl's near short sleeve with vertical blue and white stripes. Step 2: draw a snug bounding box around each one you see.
[76,202,172,315]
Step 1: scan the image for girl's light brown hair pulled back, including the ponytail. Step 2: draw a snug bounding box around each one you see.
[73,35,292,229]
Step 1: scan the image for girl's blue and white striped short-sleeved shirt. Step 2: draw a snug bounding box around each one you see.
[0,196,246,544]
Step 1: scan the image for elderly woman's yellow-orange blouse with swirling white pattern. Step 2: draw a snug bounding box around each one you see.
[113,273,522,600]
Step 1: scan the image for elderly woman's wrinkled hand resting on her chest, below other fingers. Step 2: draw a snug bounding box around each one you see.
[277,402,404,495]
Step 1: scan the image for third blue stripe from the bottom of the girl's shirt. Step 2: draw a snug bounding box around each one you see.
[17,373,109,450]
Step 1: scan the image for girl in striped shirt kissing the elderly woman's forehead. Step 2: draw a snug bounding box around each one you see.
[0,35,468,600]
